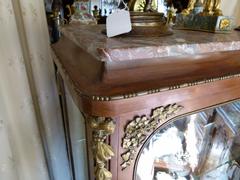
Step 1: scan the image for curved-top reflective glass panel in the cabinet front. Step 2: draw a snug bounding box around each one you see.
[135,102,240,180]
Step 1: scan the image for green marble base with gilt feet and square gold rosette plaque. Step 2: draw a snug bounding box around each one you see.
[176,0,234,33]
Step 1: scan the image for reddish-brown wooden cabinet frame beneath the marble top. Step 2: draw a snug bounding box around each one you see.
[52,33,240,180]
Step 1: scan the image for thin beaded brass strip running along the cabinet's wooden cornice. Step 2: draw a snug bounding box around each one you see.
[91,74,240,101]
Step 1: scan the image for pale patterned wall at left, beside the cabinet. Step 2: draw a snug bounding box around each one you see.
[0,0,71,180]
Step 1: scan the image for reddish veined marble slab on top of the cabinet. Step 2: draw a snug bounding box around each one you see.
[62,24,240,61]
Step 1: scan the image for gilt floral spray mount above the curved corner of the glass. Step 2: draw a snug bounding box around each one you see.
[121,104,183,170]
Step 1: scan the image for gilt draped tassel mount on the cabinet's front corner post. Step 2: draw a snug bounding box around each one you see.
[90,117,115,180]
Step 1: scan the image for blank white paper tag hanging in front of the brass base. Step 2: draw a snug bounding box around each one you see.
[106,9,132,37]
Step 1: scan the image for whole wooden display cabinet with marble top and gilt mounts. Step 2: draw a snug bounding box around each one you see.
[52,24,240,180]
